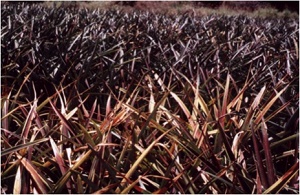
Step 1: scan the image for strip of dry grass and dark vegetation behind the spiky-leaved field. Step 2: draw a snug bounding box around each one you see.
[41,1,299,19]
